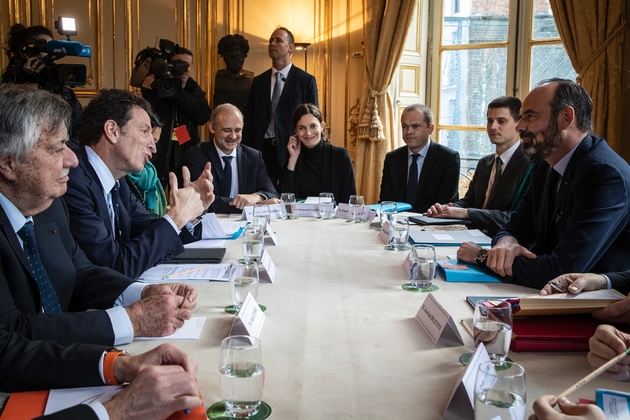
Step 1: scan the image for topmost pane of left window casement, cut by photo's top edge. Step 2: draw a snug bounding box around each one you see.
[442,0,510,45]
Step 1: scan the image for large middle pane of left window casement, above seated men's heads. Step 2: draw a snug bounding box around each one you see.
[439,48,507,126]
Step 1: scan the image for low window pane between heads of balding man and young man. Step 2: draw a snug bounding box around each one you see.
[439,130,494,174]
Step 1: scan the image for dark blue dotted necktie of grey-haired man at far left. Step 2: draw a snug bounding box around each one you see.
[18,221,61,314]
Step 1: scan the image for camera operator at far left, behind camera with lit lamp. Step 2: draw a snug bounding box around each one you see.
[2,23,85,148]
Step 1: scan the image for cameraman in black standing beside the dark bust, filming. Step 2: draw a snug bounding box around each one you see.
[131,39,210,187]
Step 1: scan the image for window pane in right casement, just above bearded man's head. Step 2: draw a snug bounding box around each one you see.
[529,44,577,89]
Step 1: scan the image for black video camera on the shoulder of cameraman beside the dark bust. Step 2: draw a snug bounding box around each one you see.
[129,39,188,98]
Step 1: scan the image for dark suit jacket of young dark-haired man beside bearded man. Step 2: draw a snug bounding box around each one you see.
[453,144,531,236]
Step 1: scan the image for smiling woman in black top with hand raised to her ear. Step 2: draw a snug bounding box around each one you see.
[283,104,356,203]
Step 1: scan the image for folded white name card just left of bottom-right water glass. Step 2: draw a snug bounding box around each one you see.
[442,343,490,420]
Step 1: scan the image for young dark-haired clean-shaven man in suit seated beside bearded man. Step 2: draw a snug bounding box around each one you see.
[427,96,531,236]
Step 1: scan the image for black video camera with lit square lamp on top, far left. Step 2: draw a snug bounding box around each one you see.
[8,17,92,91]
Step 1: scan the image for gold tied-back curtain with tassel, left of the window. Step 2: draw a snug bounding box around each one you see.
[355,0,416,203]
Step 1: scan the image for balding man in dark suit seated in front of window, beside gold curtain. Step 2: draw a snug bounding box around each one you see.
[380,104,459,213]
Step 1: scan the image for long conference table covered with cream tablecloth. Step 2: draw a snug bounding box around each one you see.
[122,217,616,420]
